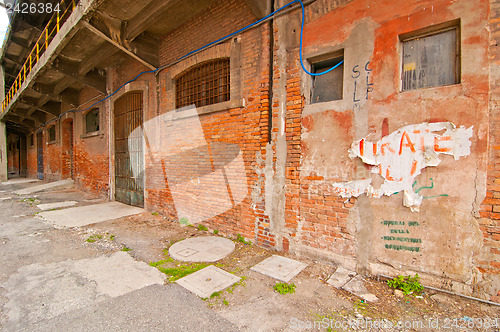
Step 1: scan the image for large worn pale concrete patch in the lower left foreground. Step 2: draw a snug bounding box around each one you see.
[2,252,165,330]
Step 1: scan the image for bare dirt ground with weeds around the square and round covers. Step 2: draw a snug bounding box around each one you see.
[60,213,500,331]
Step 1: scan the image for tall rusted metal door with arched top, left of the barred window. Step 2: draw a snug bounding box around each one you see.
[114,91,144,207]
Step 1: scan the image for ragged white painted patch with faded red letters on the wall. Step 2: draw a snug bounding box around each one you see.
[333,122,472,211]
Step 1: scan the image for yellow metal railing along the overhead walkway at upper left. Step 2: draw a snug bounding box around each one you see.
[2,0,79,113]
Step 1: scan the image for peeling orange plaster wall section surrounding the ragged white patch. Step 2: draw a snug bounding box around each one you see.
[288,0,497,297]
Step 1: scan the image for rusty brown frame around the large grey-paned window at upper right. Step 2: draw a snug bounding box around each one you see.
[399,19,462,92]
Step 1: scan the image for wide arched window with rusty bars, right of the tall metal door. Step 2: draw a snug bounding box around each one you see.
[175,58,230,108]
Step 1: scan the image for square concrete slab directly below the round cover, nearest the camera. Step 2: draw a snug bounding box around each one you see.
[176,265,240,298]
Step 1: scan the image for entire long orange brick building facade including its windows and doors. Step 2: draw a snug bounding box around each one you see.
[3,0,500,301]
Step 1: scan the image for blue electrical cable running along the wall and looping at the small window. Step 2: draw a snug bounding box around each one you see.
[37,0,338,127]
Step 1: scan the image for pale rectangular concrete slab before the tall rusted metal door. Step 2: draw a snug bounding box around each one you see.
[37,202,144,227]
